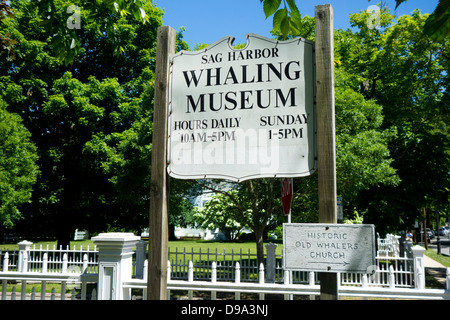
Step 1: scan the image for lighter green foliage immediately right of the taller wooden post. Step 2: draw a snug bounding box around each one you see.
[336,80,399,201]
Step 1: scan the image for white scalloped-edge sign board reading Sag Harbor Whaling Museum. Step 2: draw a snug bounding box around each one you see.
[167,34,317,181]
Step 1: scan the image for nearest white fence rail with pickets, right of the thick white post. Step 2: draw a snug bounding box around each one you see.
[123,262,450,300]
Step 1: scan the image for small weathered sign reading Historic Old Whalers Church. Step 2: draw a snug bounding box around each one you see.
[283,223,376,273]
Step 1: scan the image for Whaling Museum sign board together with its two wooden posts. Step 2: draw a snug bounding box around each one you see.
[147,5,338,300]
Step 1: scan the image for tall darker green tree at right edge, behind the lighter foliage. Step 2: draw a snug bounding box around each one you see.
[337,9,450,231]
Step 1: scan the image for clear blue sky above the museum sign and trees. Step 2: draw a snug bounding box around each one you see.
[154,0,439,49]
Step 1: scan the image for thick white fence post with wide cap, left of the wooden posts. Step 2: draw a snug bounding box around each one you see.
[92,232,141,300]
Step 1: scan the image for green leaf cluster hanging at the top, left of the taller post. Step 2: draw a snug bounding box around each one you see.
[261,0,301,39]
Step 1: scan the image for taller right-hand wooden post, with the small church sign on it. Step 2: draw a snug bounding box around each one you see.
[315,4,338,300]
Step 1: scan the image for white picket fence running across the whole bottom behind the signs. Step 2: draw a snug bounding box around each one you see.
[0,234,450,300]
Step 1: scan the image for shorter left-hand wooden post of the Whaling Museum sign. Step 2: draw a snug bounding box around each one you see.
[147,26,176,300]
